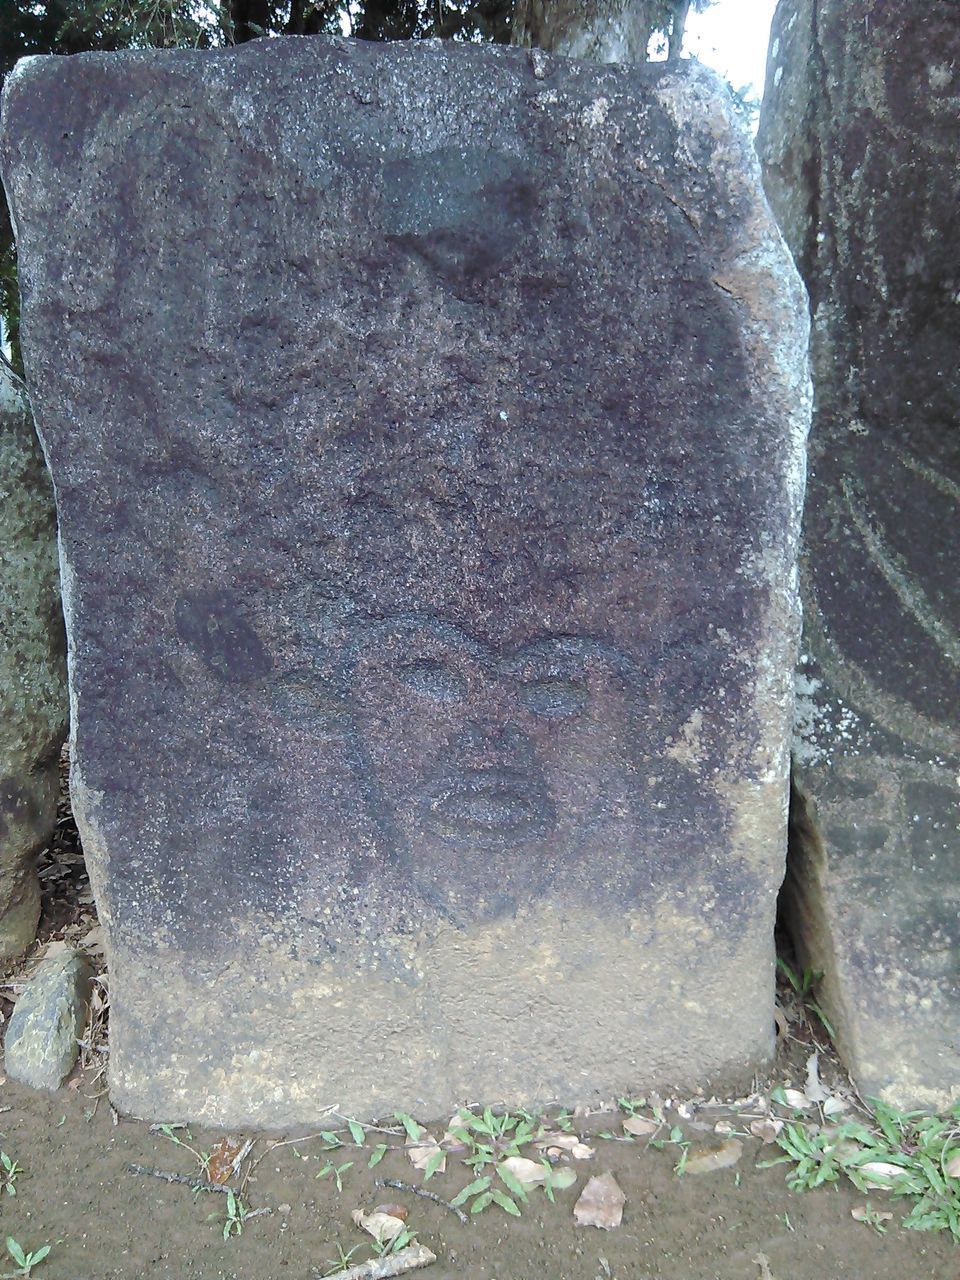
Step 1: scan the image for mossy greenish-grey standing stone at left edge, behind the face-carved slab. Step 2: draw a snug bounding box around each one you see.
[0,365,67,970]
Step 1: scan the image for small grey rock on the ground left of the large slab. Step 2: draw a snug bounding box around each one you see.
[4,947,92,1089]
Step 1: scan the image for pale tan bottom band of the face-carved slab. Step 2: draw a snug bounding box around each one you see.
[110,901,773,1129]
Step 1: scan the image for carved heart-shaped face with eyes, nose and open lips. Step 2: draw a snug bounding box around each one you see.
[348,616,647,922]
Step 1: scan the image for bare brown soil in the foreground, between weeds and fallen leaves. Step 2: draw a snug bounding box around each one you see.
[0,1083,960,1280]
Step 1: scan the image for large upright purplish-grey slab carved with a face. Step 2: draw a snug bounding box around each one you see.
[3,40,809,1125]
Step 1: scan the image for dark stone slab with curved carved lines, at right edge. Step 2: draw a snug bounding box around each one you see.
[759,0,960,1107]
